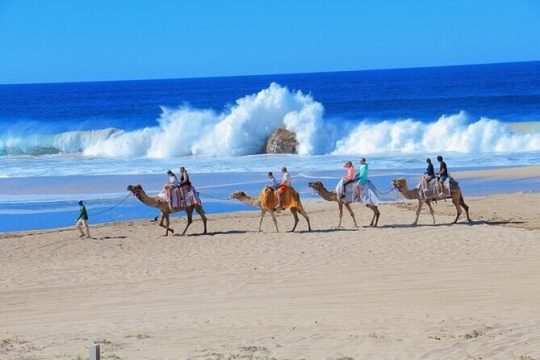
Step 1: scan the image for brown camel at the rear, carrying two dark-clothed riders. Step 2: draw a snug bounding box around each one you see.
[392,178,471,225]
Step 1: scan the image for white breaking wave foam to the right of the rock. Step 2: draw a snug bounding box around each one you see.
[334,111,540,154]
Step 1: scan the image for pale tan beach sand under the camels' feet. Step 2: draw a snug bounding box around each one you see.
[0,186,540,359]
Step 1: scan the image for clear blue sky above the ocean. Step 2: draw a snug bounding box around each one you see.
[0,0,540,84]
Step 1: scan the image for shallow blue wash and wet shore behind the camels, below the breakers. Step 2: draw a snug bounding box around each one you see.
[0,165,540,234]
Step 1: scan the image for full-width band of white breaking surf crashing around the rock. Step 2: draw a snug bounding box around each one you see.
[0,83,540,159]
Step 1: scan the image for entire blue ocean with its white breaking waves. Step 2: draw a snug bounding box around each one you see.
[0,61,540,232]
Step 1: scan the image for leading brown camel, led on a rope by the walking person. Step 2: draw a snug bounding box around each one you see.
[127,185,206,236]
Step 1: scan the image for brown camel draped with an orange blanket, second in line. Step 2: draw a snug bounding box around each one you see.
[231,187,311,232]
